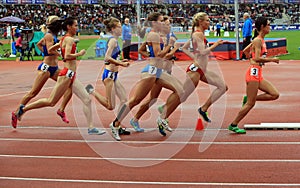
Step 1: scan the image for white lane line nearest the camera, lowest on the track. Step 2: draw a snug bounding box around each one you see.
[0,176,300,187]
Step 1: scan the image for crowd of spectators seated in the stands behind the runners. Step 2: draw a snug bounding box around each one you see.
[0,4,300,34]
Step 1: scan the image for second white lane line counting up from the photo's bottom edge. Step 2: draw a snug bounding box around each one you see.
[0,155,300,163]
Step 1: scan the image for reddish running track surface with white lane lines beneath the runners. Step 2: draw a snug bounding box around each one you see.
[0,61,300,188]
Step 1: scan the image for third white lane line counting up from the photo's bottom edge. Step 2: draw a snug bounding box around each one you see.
[0,138,300,146]
